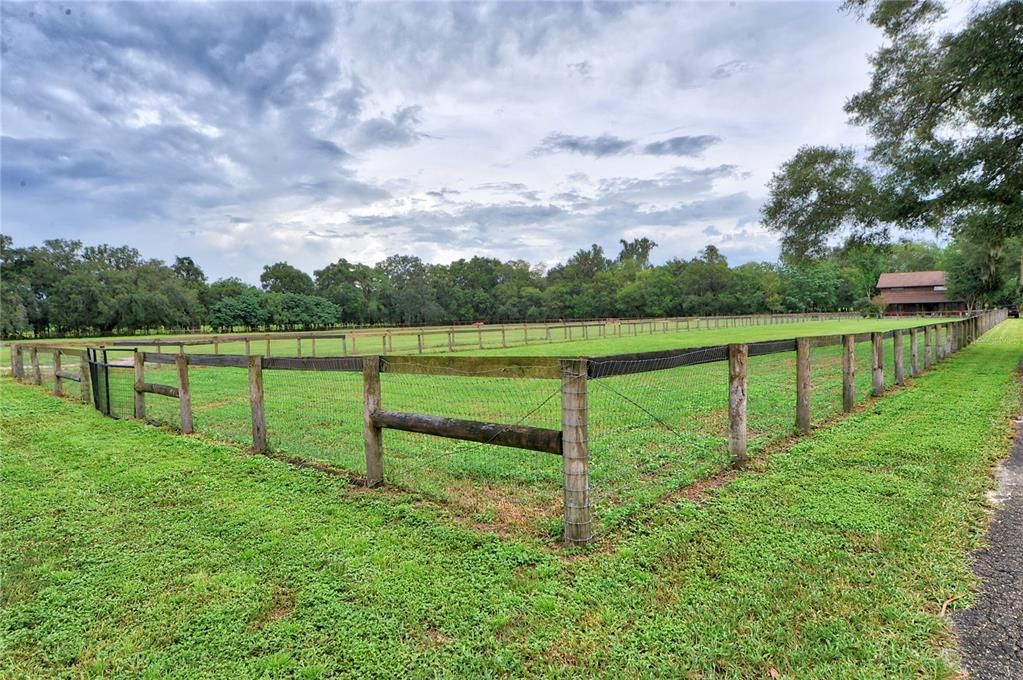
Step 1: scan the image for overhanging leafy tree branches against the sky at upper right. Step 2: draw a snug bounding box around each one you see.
[763,0,1023,259]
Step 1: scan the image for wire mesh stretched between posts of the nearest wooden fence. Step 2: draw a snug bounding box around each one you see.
[3,310,1002,533]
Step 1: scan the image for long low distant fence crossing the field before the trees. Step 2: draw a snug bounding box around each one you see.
[3,312,861,357]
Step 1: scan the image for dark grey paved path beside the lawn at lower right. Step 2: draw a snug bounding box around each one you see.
[952,404,1023,680]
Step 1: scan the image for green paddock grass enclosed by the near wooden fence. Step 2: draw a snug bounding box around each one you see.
[14,320,957,540]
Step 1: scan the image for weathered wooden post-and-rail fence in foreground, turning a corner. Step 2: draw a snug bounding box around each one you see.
[11,310,1008,545]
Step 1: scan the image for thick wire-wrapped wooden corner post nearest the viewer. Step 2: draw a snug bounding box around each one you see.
[562,359,593,546]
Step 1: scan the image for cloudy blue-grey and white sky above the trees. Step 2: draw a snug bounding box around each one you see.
[0,2,881,280]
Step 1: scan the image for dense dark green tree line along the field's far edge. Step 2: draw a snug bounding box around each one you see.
[0,236,1020,337]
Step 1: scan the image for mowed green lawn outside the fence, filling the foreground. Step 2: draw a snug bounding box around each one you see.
[0,321,1023,678]
